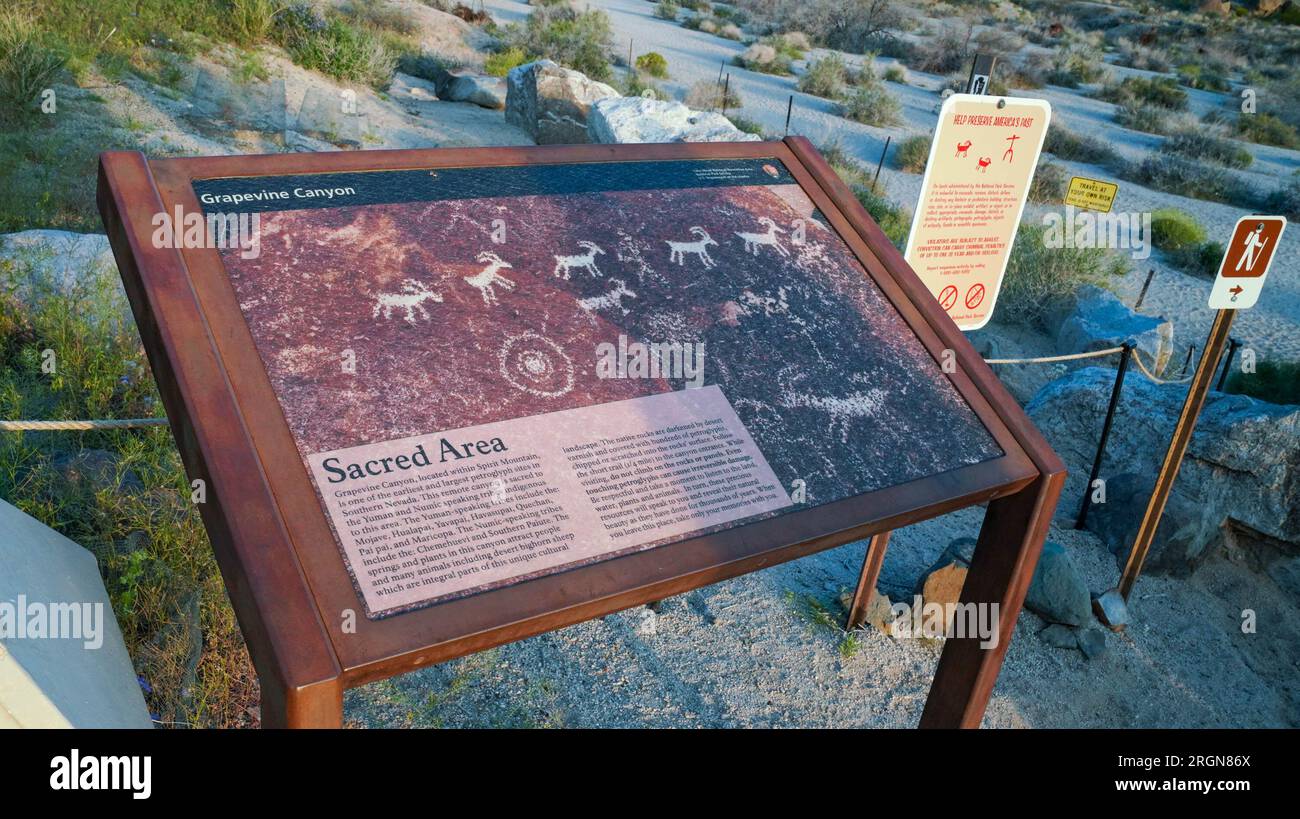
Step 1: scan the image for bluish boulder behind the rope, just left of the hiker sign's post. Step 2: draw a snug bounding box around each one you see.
[1057,285,1174,373]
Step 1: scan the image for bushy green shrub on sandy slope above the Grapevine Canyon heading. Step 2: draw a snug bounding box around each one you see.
[274,4,398,88]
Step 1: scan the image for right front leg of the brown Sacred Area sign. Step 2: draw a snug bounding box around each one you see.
[920,469,1065,728]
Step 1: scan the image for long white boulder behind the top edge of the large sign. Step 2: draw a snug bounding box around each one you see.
[588,96,758,144]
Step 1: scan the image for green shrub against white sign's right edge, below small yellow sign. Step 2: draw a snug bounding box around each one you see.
[997,224,1113,332]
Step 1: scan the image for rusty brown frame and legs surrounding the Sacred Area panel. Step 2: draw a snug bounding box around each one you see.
[98,137,1065,727]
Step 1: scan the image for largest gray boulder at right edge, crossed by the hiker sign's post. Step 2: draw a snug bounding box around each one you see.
[1026,367,1300,551]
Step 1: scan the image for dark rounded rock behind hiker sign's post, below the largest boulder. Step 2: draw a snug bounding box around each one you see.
[1088,472,1223,577]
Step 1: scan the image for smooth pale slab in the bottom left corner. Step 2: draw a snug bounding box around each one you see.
[0,501,153,728]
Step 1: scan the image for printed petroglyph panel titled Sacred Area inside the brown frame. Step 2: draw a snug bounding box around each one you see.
[195,160,1002,616]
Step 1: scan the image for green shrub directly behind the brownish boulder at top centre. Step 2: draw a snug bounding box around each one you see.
[501,5,614,82]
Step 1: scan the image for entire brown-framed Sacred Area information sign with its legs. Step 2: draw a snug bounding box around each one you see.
[99,138,1065,727]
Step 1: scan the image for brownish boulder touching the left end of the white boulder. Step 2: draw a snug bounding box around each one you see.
[506,60,619,146]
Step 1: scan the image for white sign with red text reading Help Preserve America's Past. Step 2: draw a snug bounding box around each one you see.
[904,94,1052,330]
